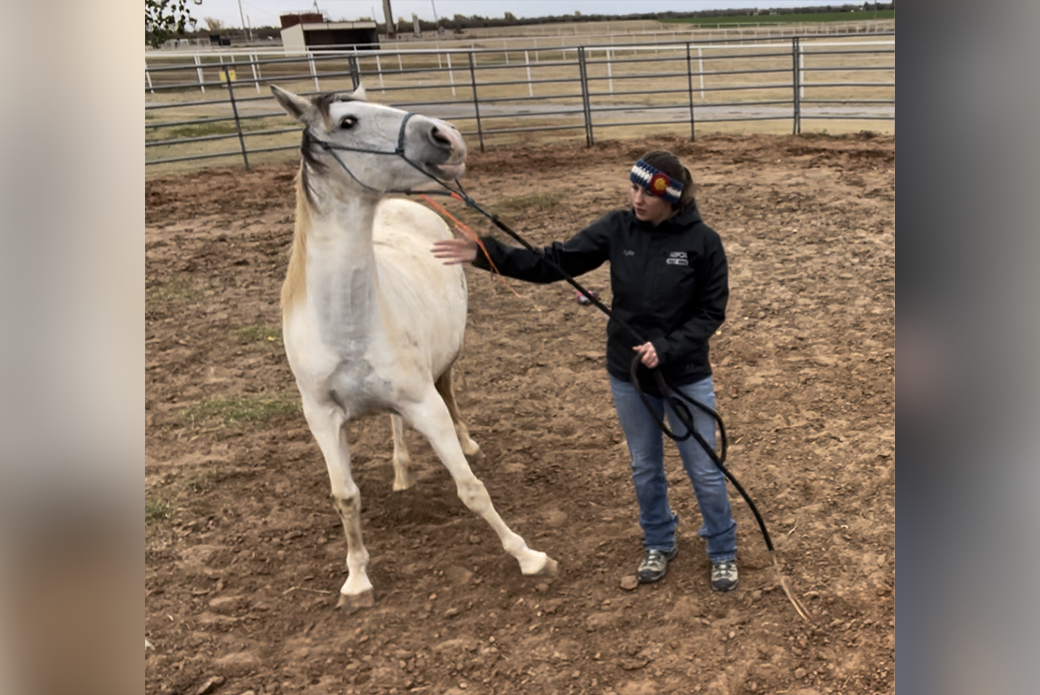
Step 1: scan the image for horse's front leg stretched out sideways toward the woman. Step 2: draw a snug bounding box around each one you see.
[398,384,556,576]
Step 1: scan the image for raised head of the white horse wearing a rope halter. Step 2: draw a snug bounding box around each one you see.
[270,85,466,194]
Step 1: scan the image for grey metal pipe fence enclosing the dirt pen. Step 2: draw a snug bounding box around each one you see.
[145,32,895,168]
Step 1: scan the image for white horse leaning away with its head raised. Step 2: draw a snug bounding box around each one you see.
[271,86,556,607]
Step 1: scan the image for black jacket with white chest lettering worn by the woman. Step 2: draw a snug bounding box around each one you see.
[473,205,729,393]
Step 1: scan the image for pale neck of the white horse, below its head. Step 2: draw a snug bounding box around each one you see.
[282,170,380,324]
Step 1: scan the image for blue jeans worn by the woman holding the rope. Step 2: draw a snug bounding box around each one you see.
[610,377,736,563]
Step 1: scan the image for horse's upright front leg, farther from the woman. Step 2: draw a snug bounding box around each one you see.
[304,398,374,609]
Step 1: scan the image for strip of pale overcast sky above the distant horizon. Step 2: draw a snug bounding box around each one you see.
[196,0,852,28]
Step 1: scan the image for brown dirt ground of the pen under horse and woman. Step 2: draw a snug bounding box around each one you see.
[145,133,895,695]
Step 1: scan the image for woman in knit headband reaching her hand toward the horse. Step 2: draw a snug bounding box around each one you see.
[434,151,737,591]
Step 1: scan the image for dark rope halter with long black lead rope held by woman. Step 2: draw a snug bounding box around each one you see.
[307,112,812,622]
